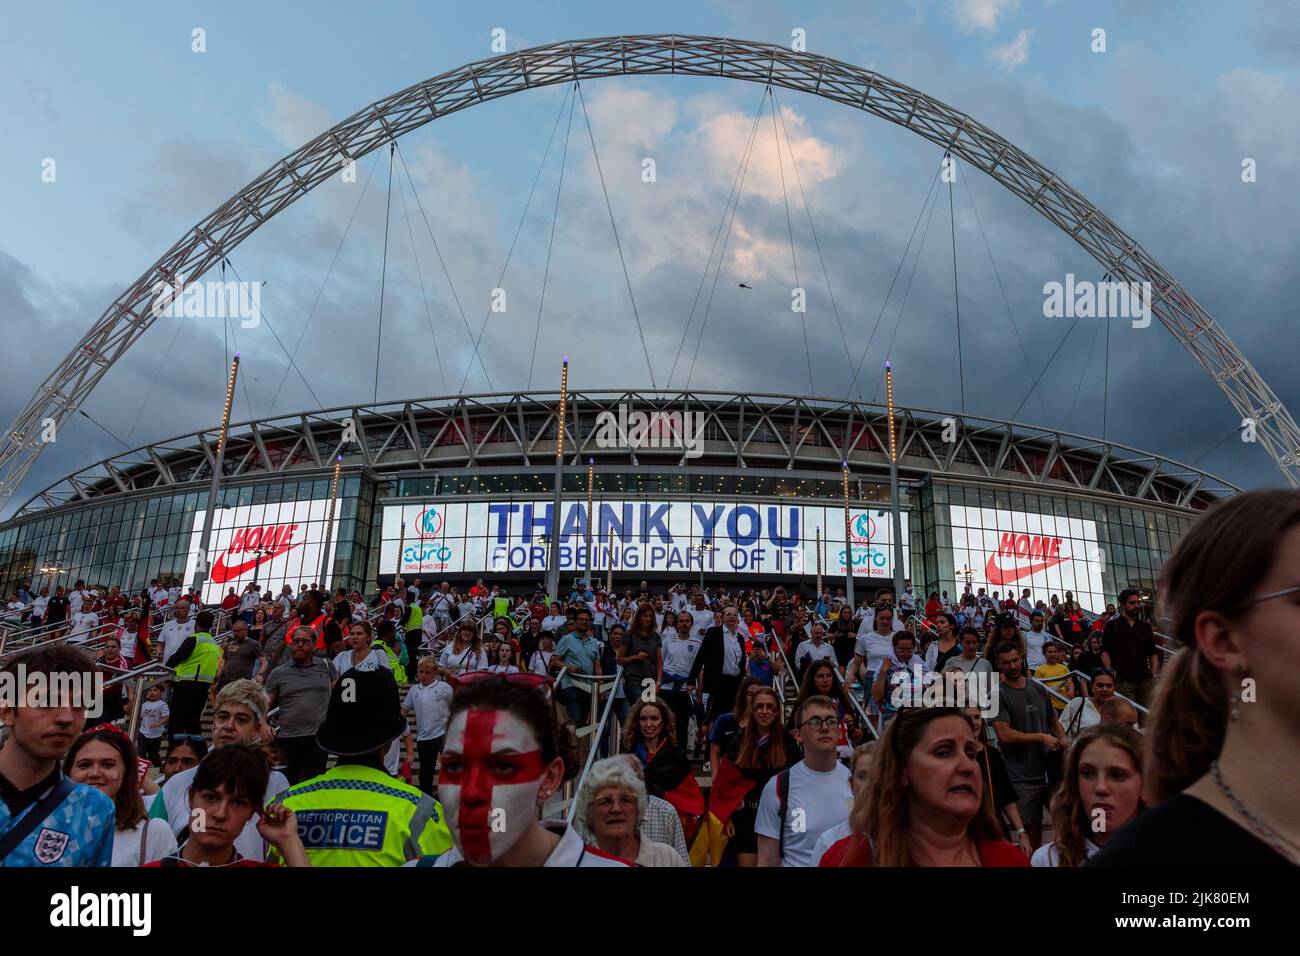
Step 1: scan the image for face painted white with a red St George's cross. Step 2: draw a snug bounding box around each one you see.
[438,710,545,866]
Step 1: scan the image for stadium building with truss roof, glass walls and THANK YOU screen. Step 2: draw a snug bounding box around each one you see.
[0,390,1238,610]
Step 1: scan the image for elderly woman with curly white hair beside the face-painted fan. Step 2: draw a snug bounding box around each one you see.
[573,754,686,866]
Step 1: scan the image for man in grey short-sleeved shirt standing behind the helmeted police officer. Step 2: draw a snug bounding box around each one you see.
[267,627,338,784]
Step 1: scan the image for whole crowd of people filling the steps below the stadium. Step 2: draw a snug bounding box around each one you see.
[0,490,1300,868]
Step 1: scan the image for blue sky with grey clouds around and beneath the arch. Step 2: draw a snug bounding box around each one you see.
[0,0,1300,514]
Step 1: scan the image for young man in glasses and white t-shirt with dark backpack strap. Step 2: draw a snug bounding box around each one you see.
[754,695,853,866]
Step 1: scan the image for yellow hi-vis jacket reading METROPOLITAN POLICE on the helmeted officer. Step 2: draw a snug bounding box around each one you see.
[273,763,451,866]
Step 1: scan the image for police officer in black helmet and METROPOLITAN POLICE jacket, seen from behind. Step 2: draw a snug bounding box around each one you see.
[280,667,451,866]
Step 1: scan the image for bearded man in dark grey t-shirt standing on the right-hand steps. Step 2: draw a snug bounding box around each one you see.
[993,641,1069,849]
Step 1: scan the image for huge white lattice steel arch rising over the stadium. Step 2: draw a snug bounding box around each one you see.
[0,34,1300,497]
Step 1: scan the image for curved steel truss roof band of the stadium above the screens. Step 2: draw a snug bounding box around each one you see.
[10,389,1239,524]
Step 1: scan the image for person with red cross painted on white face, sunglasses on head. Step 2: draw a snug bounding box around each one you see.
[426,674,627,866]
